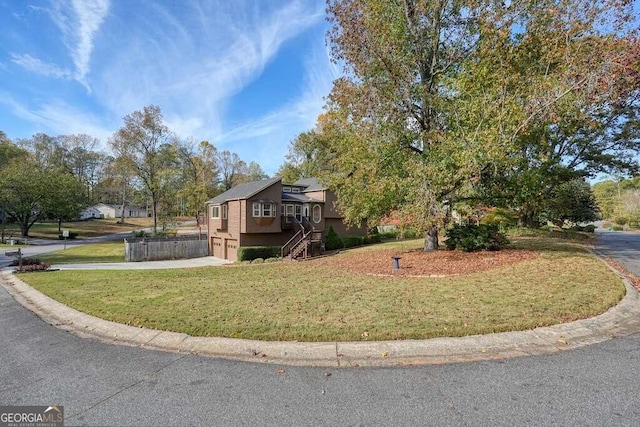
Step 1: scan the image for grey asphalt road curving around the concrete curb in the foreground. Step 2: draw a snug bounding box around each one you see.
[0,235,640,426]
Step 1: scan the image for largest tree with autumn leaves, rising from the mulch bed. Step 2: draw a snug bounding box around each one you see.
[323,0,637,250]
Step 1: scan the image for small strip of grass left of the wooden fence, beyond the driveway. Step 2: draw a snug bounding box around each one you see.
[35,241,124,264]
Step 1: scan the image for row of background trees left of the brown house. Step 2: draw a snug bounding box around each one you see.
[0,105,267,239]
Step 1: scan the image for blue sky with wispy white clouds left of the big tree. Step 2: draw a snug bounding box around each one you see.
[0,0,340,175]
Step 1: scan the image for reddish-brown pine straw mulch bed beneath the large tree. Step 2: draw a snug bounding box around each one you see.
[314,249,539,277]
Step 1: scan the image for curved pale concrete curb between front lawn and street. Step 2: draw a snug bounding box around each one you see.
[0,261,640,368]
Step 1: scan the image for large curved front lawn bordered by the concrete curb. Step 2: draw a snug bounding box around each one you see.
[20,238,625,341]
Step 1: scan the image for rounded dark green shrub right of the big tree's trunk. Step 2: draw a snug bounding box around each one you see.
[444,224,509,252]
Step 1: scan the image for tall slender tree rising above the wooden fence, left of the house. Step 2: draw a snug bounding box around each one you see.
[111,105,177,232]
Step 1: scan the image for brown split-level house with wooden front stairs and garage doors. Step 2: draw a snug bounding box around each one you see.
[207,178,366,261]
